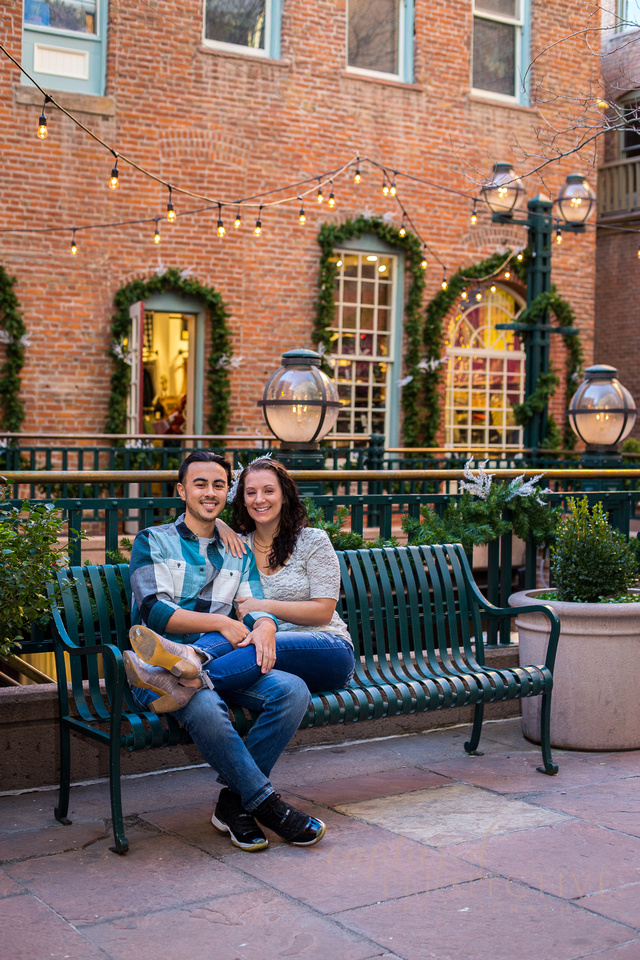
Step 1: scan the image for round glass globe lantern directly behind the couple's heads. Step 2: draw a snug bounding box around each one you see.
[258,350,340,449]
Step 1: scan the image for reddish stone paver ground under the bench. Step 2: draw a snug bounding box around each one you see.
[0,720,640,960]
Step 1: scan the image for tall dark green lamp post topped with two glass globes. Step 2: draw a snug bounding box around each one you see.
[481,163,596,450]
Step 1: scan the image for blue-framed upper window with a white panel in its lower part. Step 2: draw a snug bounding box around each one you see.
[22,0,107,96]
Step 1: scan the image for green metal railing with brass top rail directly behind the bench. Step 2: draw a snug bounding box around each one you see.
[5,469,640,650]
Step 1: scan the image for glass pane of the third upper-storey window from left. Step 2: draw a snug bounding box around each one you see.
[347,0,400,73]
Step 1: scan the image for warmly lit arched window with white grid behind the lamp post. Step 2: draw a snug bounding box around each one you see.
[445,287,525,450]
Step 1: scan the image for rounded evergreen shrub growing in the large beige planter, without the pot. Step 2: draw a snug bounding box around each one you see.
[551,497,638,603]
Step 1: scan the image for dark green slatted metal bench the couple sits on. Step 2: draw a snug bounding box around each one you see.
[50,544,560,853]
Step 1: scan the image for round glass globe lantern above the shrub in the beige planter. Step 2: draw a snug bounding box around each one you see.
[568,364,636,454]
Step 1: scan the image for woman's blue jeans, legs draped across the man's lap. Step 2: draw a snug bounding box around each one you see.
[197,630,354,693]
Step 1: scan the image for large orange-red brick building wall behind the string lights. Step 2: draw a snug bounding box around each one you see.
[0,0,603,444]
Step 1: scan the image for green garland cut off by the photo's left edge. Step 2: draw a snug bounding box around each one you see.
[0,266,27,433]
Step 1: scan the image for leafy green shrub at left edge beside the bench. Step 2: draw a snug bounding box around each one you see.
[0,478,67,657]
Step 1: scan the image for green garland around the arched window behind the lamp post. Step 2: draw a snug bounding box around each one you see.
[419,251,583,449]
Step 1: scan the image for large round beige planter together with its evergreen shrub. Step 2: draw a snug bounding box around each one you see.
[509,497,640,750]
